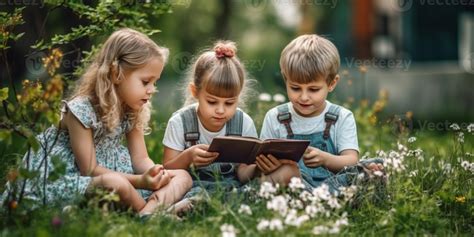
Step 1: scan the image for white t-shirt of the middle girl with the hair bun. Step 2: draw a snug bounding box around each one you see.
[163,108,258,151]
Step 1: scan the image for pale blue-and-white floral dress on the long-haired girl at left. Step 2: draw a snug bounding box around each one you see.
[3,97,151,204]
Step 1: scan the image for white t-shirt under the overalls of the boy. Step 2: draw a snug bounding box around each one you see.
[260,101,359,154]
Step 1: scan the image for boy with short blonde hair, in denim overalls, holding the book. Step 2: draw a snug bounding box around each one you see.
[259,34,383,192]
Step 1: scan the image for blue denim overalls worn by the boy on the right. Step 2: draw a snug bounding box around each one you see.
[278,104,383,193]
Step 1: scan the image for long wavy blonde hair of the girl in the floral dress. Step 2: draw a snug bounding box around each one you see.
[71,28,169,133]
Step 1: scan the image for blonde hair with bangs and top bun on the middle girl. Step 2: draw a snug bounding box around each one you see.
[184,41,248,105]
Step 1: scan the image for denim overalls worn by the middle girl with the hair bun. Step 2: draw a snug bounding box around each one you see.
[179,105,243,198]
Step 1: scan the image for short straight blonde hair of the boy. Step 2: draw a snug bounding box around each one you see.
[280,34,341,84]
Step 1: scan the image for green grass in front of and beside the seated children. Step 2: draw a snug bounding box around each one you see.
[0,97,474,236]
